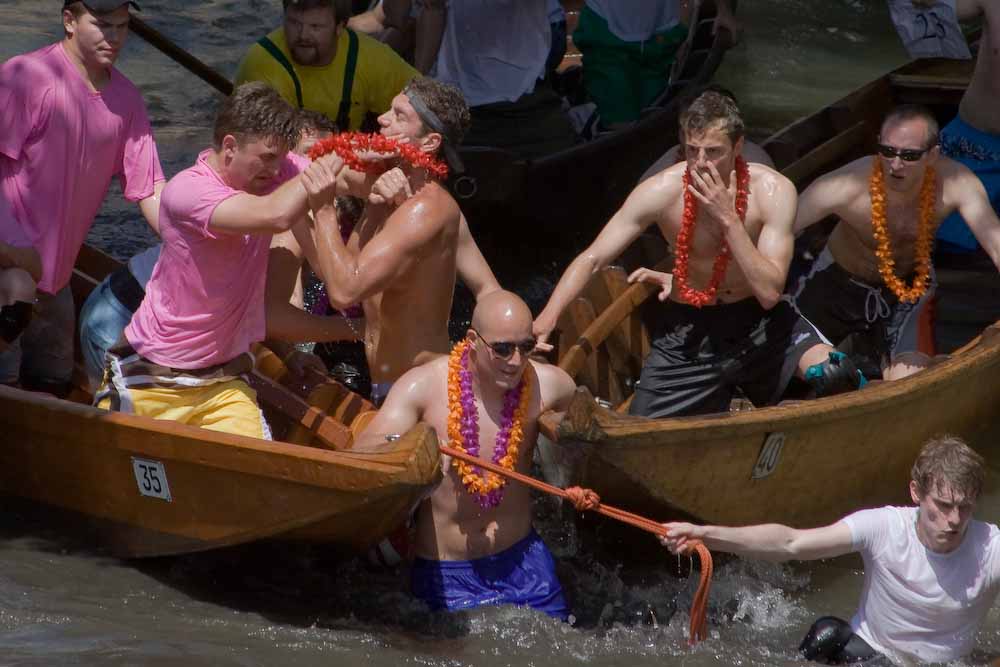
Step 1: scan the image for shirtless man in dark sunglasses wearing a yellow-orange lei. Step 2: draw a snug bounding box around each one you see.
[795,105,1000,380]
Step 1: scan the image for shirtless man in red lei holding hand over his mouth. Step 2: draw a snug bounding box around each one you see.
[534,92,825,417]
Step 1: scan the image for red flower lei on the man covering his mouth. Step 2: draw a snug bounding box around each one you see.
[674,157,750,308]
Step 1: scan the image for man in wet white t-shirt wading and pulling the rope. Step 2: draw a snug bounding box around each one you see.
[662,436,1000,664]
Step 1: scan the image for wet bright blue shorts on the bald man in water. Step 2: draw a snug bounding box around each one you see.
[410,530,569,621]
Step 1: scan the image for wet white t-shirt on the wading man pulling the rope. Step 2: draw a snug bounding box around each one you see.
[843,507,1000,662]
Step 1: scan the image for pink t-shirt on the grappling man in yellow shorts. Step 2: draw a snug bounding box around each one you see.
[125,150,309,370]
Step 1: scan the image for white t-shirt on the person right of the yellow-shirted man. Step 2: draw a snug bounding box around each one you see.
[431,0,552,107]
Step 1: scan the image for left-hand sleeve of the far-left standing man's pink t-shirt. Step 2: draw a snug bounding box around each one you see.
[0,57,52,160]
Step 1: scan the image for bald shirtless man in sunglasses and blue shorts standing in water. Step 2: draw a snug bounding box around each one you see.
[356,291,575,619]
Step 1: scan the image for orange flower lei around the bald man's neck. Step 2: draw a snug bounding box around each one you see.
[448,340,531,507]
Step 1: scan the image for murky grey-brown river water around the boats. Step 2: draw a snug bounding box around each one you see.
[0,0,1000,667]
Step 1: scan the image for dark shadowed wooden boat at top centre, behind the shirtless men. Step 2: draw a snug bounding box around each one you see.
[452,0,735,250]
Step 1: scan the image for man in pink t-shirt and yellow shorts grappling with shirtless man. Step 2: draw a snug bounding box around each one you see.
[95,82,339,438]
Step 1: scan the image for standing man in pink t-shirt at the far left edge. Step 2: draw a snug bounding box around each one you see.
[0,0,163,393]
